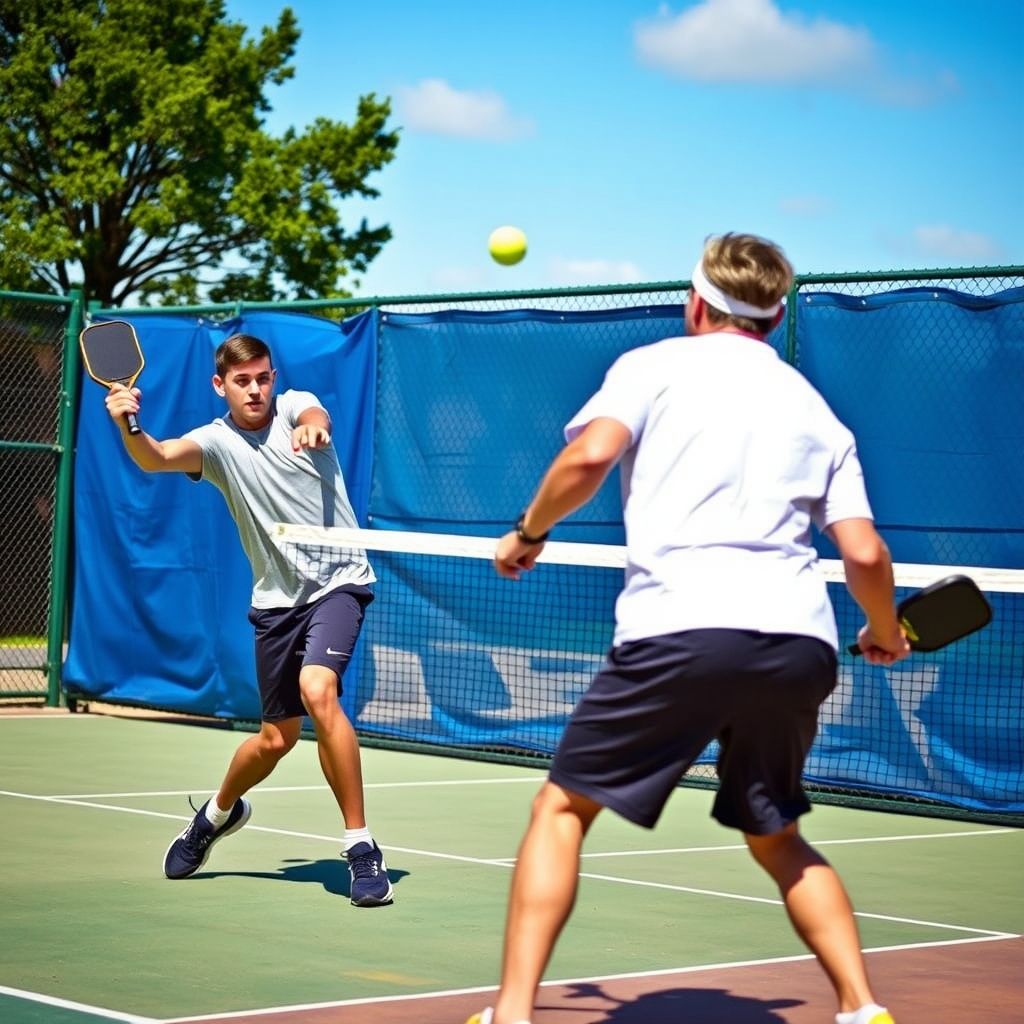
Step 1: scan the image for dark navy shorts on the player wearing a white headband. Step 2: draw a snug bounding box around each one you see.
[551,630,837,836]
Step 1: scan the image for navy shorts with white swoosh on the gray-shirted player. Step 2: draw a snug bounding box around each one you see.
[249,584,374,722]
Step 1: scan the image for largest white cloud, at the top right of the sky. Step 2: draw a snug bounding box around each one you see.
[634,0,959,106]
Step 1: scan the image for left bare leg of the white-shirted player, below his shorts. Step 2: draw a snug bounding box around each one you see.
[495,782,601,1024]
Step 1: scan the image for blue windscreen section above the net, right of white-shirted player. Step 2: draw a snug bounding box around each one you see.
[797,288,1024,568]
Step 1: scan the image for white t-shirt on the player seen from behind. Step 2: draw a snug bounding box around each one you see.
[565,333,872,647]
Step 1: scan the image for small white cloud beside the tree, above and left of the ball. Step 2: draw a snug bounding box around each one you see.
[397,78,534,142]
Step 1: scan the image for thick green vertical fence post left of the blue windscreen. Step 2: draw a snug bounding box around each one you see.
[46,288,83,708]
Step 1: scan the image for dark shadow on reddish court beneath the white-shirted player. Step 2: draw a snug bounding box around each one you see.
[537,983,803,1024]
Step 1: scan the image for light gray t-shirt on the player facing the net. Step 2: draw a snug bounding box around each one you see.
[184,391,377,608]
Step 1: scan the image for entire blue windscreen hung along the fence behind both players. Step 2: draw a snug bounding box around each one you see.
[65,288,1024,811]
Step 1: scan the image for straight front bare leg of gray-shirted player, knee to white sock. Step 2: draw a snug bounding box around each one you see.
[299,665,367,828]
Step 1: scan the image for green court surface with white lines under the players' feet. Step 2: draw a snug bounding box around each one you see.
[0,714,1024,1024]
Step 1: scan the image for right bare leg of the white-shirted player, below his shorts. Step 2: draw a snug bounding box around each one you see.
[744,823,876,1013]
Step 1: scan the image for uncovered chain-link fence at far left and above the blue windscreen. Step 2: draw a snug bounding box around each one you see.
[12,266,1024,703]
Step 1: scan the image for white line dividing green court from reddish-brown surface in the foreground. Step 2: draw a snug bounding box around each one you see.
[160,935,1020,1024]
